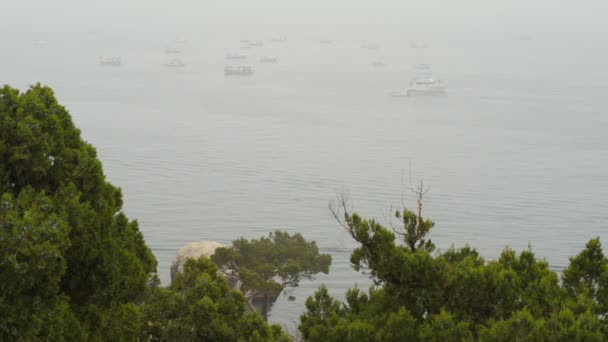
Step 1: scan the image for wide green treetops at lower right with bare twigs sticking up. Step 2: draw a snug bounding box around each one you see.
[299,202,608,341]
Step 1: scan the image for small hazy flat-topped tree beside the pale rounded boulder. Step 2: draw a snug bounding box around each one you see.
[211,231,331,317]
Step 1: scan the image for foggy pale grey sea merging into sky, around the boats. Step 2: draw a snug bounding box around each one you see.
[0,0,608,324]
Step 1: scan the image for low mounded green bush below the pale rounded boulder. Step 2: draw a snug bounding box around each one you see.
[140,257,290,342]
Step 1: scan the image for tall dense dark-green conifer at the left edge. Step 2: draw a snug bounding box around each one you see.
[0,85,156,340]
